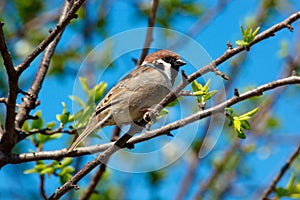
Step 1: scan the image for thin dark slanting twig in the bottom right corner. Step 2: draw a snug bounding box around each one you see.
[260,144,300,200]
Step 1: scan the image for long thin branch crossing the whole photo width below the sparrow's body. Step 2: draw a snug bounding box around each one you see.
[0,76,300,167]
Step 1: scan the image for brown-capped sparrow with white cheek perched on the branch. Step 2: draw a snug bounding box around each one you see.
[68,50,186,152]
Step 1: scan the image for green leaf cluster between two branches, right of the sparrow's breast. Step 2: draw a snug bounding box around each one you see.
[192,79,217,108]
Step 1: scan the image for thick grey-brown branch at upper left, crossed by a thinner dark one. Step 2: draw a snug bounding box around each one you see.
[15,0,76,128]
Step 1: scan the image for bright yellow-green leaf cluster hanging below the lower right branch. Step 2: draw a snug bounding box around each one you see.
[225,108,259,139]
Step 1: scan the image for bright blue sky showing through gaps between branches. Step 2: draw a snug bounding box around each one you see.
[0,0,300,199]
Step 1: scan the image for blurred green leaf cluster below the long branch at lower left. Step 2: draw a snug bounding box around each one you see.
[24,158,75,184]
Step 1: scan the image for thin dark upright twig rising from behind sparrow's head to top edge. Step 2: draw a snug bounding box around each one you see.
[137,0,159,66]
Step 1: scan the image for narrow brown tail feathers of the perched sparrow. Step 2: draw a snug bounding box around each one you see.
[68,114,111,152]
